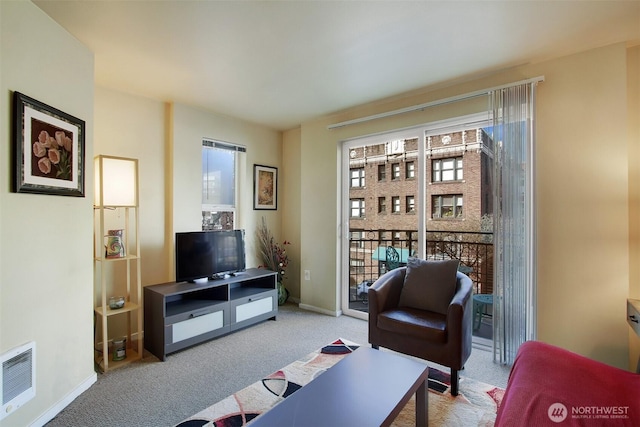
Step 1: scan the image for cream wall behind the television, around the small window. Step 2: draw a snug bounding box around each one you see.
[95,93,283,286]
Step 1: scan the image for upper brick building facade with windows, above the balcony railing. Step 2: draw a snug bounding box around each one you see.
[349,129,493,236]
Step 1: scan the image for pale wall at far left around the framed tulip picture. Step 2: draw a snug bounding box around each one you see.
[0,1,96,426]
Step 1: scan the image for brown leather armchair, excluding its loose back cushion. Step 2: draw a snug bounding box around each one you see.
[369,267,473,396]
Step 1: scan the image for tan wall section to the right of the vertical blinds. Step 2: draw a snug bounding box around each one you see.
[532,44,629,368]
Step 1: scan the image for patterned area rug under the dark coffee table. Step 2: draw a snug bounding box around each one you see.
[176,339,504,427]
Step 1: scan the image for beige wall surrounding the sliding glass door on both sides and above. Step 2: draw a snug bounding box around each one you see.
[300,44,637,368]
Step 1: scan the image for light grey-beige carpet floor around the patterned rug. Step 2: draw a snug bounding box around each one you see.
[47,304,509,427]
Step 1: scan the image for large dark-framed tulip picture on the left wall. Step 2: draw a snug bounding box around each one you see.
[13,92,85,197]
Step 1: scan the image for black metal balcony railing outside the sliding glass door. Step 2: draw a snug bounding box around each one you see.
[349,230,493,303]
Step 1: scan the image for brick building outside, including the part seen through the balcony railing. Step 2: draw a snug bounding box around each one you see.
[349,128,493,298]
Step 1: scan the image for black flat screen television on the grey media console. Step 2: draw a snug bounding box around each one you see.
[176,230,246,282]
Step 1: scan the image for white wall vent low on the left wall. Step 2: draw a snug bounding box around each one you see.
[0,342,36,420]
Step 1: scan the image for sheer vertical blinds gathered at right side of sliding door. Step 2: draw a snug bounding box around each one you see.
[490,83,536,364]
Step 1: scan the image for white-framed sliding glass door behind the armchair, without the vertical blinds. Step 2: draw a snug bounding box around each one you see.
[342,112,493,326]
